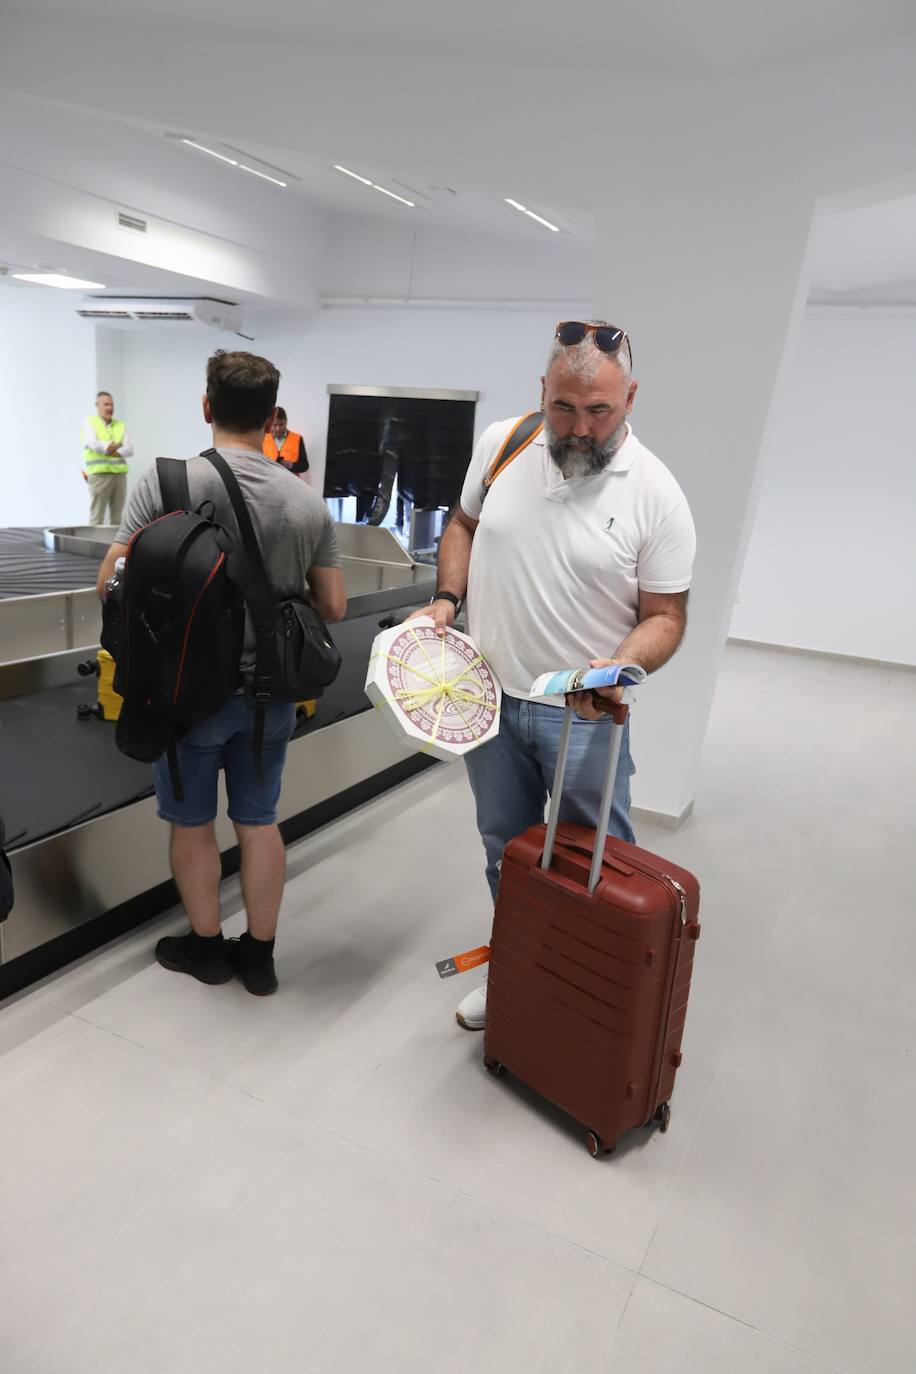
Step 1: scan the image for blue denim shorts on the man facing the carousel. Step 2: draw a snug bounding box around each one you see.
[152,695,295,826]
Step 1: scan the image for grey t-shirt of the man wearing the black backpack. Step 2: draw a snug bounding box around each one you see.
[115,448,341,672]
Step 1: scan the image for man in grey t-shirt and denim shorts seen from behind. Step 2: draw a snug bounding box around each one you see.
[99,349,346,996]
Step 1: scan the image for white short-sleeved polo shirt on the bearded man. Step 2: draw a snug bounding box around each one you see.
[461,416,696,705]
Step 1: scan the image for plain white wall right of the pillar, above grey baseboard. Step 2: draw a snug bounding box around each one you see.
[731,309,916,664]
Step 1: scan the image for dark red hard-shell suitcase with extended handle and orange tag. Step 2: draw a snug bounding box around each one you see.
[483,705,700,1158]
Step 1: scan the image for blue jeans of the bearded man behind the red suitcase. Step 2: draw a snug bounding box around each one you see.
[464,695,636,901]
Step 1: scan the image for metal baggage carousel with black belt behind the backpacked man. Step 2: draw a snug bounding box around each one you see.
[0,526,435,998]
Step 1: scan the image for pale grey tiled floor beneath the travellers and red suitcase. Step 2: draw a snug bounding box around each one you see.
[0,646,916,1374]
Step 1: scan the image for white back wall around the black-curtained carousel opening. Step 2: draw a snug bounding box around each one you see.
[119,306,574,491]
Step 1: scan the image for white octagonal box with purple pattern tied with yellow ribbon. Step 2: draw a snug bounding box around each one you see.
[365,616,503,758]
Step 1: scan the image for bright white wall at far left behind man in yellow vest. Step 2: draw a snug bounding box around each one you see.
[0,286,98,526]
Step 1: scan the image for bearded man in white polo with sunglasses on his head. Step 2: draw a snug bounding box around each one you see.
[414,320,696,1031]
